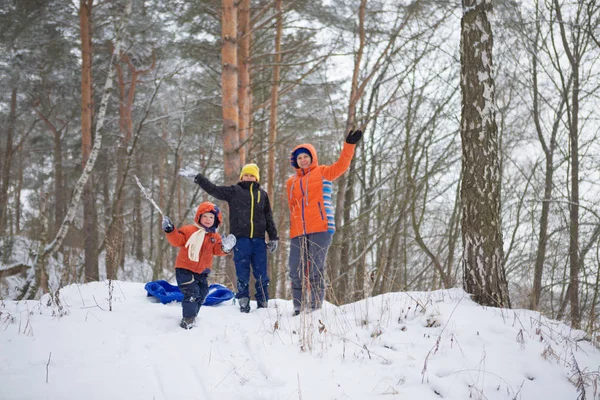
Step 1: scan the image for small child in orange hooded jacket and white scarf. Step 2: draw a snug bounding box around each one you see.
[162,201,236,329]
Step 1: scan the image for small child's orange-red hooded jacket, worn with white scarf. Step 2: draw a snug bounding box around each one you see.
[167,201,228,274]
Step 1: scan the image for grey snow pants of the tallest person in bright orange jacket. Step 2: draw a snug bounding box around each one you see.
[290,232,333,310]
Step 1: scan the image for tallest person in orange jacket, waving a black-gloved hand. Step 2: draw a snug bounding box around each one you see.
[287,130,362,315]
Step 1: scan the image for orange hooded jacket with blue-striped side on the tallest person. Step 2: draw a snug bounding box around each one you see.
[287,142,356,238]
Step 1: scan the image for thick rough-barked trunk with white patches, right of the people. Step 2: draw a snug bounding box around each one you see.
[460,0,510,307]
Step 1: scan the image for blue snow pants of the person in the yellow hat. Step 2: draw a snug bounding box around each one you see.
[233,237,269,303]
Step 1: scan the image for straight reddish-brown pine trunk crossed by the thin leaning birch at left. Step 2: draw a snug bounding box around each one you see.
[79,0,99,281]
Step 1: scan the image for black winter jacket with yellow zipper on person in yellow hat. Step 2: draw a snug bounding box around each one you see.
[194,174,279,240]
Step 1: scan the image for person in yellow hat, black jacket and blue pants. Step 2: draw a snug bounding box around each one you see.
[179,164,279,313]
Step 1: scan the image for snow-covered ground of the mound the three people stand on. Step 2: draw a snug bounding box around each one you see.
[0,282,600,400]
